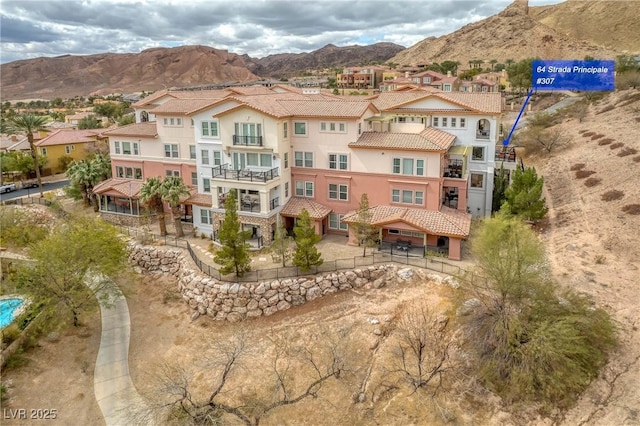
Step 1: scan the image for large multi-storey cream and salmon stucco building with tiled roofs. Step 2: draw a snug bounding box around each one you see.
[96,86,503,259]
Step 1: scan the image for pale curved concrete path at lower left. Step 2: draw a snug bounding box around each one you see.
[93,278,149,426]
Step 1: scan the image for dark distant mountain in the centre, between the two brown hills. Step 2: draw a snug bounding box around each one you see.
[245,43,405,78]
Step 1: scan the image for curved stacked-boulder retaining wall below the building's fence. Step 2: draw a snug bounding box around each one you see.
[129,243,413,322]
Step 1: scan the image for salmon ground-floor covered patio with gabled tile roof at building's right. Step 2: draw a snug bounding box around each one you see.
[342,206,471,260]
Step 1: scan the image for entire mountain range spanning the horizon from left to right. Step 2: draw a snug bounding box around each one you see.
[0,0,640,100]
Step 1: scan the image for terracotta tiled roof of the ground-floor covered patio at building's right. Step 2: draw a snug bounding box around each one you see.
[342,206,471,238]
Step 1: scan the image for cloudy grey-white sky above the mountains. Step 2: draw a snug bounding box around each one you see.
[0,0,561,63]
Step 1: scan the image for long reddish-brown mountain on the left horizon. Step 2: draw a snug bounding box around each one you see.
[1,46,258,99]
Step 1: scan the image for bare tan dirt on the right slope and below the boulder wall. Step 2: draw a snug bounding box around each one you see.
[2,91,640,426]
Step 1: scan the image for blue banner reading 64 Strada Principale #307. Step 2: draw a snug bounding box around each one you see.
[531,60,615,91]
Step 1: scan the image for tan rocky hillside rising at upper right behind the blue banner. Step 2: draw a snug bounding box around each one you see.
[391,0,640,65]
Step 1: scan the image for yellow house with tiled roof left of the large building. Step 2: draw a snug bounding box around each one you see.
[35,129,107,174]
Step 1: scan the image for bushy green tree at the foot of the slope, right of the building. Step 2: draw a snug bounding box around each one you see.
[503,167,549,221]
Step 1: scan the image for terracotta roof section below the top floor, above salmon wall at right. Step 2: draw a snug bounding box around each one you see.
[349,127,456,151]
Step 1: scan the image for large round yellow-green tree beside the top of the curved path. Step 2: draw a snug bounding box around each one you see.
[16,217,127,327]
